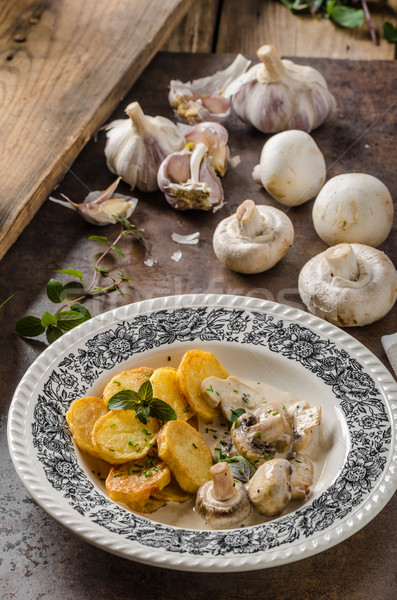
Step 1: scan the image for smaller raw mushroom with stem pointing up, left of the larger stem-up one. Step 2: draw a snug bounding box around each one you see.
[213,200,294,273]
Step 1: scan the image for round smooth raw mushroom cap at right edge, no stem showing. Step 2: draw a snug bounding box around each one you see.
[313,173,394,248]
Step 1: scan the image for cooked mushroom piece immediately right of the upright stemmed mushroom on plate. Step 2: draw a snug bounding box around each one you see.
[248,458,292,517]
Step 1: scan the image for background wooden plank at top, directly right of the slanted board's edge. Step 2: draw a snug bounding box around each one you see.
[162,0,221,52]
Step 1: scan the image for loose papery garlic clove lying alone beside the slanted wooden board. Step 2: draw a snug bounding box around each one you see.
[49,177,138,226]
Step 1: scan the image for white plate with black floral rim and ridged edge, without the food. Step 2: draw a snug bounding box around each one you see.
[8,295,397,571]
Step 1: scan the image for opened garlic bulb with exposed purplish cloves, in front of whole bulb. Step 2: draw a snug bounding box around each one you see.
[157,144,223,212]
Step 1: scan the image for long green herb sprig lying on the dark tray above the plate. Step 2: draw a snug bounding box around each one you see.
[15,215,143,344]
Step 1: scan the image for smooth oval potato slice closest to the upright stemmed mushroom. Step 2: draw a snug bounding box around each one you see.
[157,420,213,494]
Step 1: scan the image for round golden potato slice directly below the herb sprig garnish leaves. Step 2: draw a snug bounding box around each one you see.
[92,410,159,465]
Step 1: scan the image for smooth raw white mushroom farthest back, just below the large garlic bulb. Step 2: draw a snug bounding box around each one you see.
[252,130,326,206]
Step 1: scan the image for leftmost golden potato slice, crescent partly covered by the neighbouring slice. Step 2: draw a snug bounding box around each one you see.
[66,396,109,458]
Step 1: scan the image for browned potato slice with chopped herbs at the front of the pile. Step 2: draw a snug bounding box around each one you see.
[105,456,171,512]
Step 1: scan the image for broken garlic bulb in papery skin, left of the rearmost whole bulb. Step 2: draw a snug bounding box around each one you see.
[168,54,251,125]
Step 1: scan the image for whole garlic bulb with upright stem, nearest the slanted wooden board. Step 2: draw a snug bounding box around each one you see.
[105,102,185,192]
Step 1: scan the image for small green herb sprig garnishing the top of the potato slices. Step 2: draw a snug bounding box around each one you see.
[107,379,176,425]
